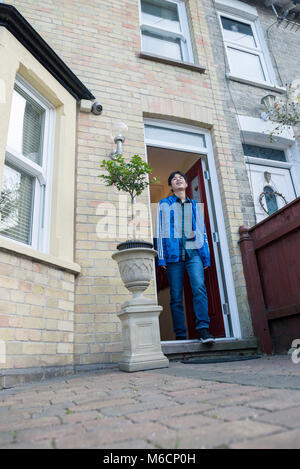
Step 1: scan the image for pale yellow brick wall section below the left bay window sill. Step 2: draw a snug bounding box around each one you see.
[0,252,74,369]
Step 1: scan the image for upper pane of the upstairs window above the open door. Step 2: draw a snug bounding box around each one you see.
[141,0,180,32]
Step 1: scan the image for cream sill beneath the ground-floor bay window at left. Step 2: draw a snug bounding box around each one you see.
[0,236,81,275]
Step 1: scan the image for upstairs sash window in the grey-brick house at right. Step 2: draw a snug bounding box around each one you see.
[219,13,273,84]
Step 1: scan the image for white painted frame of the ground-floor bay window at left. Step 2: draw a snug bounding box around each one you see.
[0,74,55,253]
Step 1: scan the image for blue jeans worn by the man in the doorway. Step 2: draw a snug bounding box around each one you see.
[167,256,209,337]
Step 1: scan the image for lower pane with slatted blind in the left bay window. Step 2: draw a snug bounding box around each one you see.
[0,165,35,244]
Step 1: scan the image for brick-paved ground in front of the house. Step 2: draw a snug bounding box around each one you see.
[0,356,300,449]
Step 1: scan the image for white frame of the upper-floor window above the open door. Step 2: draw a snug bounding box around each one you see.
[139,0,194,63]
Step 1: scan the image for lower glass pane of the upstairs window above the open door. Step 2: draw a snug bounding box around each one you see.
[142,32,183,60]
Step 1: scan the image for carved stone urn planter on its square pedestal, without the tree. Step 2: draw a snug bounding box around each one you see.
[112,241,169,372]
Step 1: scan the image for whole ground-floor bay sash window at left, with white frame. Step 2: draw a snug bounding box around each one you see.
[0,76,54,251]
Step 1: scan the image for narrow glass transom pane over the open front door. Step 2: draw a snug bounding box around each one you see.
[145,125,206,149]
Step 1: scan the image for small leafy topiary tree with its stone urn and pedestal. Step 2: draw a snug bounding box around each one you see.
[100,155,169,372]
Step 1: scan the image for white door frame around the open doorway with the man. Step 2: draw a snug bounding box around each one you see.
[144,118,241,339]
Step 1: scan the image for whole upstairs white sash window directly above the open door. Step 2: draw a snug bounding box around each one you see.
[140,0,194,62]
